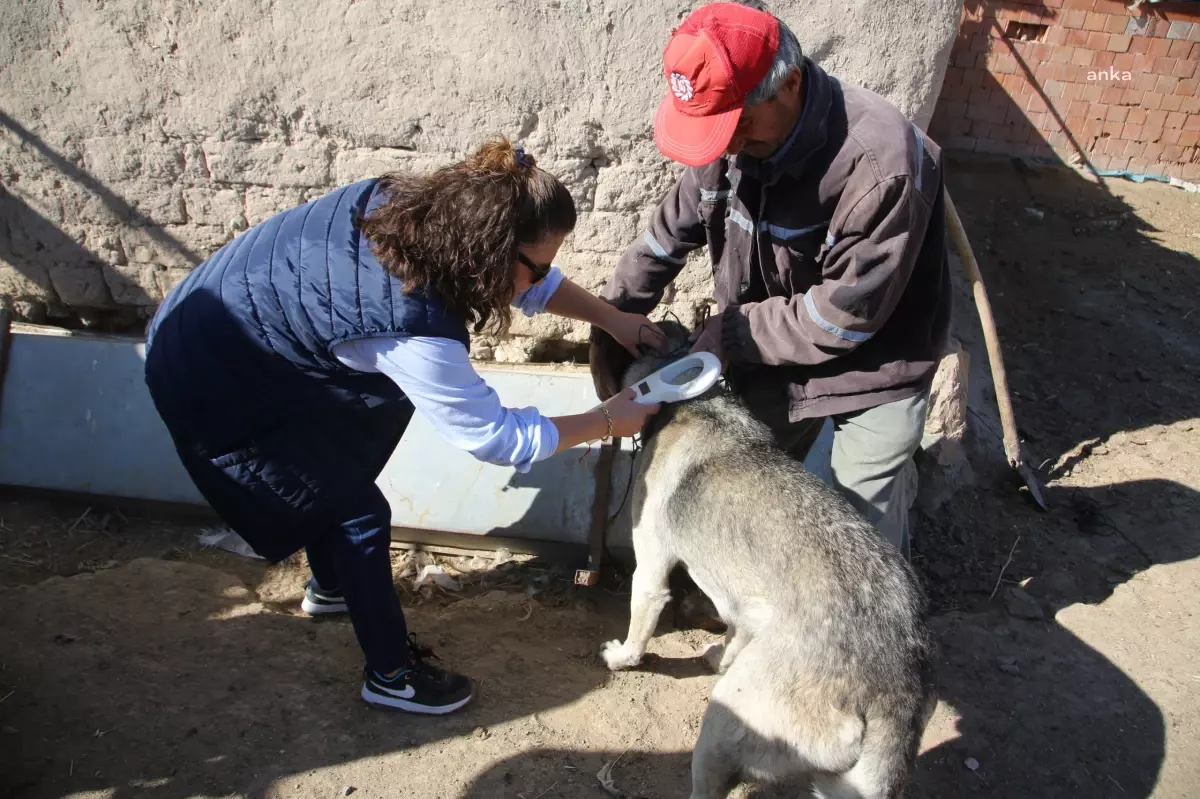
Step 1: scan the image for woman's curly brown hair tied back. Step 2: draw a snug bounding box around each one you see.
[362,137,576,334]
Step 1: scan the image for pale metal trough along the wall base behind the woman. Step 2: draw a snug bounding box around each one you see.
[0,319,830,568]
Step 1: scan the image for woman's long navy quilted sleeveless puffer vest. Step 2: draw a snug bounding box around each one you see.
[146,180,469,559]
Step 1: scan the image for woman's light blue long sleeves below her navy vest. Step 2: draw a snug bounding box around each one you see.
[334,266,564,471]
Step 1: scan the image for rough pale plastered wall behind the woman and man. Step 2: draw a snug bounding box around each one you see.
[0,0,961,361]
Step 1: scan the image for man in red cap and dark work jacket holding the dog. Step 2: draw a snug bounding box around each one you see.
[593,2,950,557]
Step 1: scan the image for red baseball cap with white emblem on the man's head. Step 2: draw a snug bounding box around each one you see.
[654,2,779,167]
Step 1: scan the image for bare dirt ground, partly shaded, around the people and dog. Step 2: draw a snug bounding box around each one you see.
[0,152,1200,799]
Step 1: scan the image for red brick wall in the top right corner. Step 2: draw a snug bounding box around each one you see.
[929,0,1200,181]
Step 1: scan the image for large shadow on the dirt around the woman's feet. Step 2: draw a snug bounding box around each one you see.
[0,559,633,799]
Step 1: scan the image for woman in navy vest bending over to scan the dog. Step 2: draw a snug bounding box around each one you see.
[146,133,662,714]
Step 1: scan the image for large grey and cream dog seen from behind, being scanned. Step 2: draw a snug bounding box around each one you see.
[593,323,936,799]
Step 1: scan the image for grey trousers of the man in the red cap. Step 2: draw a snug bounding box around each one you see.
[744,390,929,558]
